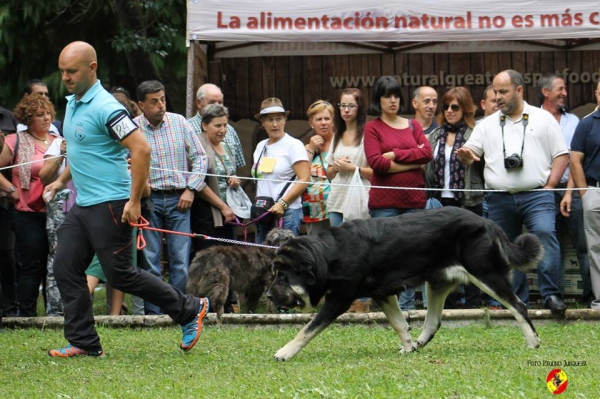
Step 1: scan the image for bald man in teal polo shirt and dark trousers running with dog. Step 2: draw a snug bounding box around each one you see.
[44,42,209,357]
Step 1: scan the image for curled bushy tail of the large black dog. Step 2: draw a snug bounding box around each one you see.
[486,220,544,271]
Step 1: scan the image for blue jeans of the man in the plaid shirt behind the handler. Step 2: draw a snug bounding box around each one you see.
[144,192,191,314]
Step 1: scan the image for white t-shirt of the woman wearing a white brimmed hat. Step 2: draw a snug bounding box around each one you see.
[252,133,308,209]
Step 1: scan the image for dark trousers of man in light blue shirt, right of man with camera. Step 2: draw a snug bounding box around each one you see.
[554,190,593,303]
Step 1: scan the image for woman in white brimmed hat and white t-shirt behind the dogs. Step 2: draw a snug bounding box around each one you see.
[252,97,310,243]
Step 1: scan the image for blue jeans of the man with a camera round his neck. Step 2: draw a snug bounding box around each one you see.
[488,191,562,305]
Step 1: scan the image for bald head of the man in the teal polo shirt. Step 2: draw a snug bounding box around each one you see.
[58,42,98,100]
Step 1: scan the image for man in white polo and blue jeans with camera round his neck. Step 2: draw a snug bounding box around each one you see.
[457,70,569,315]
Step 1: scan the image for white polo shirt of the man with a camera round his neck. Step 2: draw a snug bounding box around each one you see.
[465,102,569,192]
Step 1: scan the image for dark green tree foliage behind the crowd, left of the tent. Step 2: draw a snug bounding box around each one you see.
[0,0,187,115]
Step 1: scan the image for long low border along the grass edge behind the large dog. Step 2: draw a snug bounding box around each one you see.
[0,309,600,329]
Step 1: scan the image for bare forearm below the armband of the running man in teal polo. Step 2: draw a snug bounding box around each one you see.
[118,129,150,223]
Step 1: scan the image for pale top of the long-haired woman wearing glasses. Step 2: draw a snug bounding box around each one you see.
[327,140,371,213]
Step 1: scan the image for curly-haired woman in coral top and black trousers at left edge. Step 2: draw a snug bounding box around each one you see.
[0,94,56,317]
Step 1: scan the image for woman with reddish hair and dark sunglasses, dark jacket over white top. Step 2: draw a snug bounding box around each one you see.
[425,87,484,309]
